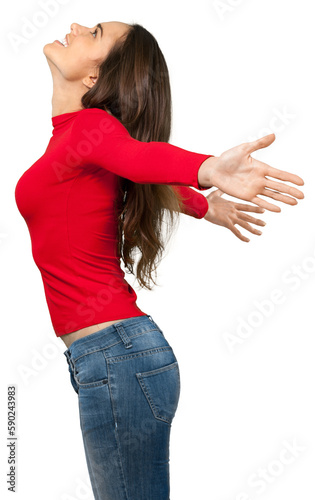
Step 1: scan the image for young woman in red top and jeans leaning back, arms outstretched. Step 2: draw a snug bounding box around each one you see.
[15,22,303,500]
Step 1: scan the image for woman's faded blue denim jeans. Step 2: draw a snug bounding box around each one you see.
[64,315,180,500]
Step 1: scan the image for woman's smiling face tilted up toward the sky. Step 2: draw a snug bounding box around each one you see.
[43,21,130,83]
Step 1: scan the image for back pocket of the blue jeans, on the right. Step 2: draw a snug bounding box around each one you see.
[136,361,180,424]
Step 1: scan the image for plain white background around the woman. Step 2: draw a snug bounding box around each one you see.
[0,0,315,500]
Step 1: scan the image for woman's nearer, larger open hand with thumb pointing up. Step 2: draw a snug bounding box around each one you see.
[198,134,304,212]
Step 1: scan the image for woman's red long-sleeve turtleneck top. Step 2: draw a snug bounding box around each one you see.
[15,108,213,337]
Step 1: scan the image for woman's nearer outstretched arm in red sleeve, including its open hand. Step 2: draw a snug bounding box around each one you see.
[71,108,304,212]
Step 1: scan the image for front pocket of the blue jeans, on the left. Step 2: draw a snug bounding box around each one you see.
[73,351,108,388]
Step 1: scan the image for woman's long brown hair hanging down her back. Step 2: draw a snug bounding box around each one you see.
[81,24,189,290]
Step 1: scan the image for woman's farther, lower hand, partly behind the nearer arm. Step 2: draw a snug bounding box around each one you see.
[204,189,266,242]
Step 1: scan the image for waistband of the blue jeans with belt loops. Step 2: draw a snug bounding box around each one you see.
[63,314,163,365]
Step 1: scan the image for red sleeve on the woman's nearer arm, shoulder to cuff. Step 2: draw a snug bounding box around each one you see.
[71,108,213,190]
